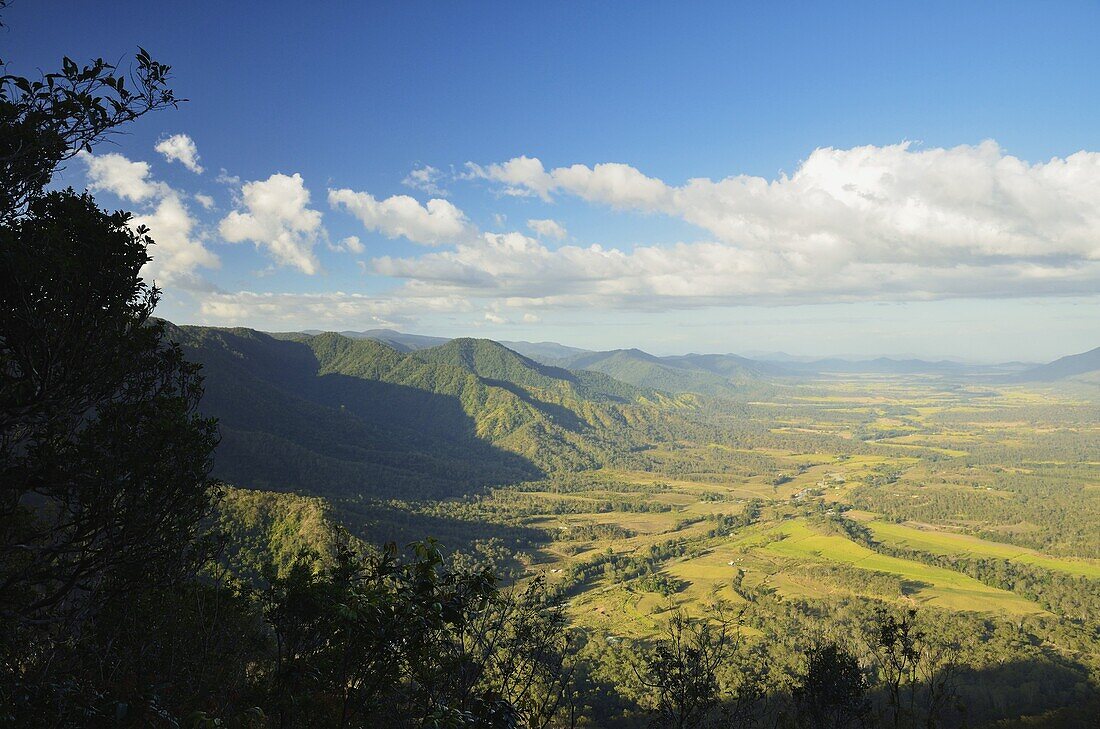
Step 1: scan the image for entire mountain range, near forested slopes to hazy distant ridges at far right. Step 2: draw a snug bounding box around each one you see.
[165,327,1100,505]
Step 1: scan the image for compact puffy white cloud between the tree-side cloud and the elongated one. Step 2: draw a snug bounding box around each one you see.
[219,173,323,275]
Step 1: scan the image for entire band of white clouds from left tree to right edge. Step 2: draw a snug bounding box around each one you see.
[80,134,1100,327]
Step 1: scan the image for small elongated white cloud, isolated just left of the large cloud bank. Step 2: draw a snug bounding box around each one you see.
[329,189,473,245]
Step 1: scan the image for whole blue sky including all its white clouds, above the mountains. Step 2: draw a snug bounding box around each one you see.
[8,0,1100,360]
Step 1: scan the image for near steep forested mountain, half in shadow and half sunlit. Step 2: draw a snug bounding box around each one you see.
[173,327,677,497]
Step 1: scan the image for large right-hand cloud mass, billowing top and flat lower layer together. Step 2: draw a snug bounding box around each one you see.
[415,142,1100,308]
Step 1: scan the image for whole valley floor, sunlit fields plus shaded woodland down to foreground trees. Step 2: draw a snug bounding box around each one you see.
[259,375,1100,727]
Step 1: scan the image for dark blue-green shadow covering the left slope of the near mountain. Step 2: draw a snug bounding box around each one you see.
[188,332,542,498]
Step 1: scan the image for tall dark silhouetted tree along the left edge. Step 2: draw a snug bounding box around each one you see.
[0,27,217,726]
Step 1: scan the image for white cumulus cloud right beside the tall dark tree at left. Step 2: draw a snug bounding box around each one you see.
[79,152,219,289]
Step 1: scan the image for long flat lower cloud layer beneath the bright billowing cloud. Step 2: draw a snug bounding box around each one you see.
[371,226,1100,309]
